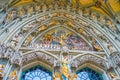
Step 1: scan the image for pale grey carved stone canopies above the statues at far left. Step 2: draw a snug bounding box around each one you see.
[0,44,22,65]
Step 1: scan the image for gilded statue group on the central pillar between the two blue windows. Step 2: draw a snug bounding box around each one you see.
[53,56,77,80]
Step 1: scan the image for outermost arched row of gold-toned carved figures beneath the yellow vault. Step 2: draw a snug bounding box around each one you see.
[0,3,117,32]
